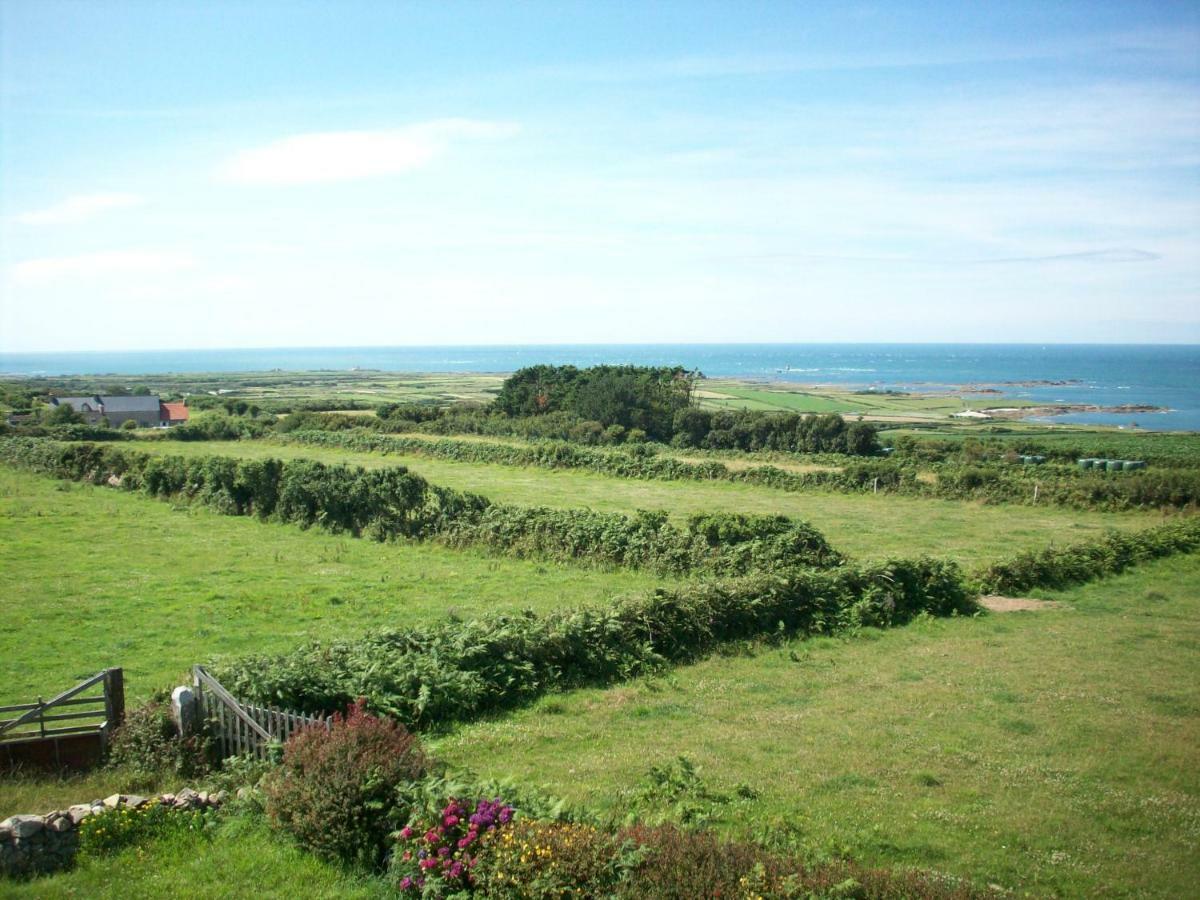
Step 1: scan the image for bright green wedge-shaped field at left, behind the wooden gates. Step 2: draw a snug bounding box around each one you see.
[0,468,656,710]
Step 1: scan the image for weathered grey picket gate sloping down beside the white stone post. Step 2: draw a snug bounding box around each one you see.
[192,666,332,760]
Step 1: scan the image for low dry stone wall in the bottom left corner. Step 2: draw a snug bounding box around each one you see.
[0,787,226,877]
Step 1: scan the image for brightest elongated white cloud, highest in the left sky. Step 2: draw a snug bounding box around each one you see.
[218,119,516,185]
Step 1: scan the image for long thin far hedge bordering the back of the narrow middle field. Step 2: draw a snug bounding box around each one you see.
[276,430,1200,510]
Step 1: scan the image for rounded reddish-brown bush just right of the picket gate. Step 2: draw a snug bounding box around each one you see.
[263,703,426,866]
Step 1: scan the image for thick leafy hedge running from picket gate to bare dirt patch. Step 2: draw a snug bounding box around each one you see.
[214,558,974,728]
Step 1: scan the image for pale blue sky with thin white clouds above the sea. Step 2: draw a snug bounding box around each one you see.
[0,0,1200,352]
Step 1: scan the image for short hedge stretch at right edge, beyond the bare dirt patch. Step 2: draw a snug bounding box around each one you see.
[979,517,1200,594]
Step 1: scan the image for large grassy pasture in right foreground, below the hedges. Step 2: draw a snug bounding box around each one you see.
[436,554,1200,896]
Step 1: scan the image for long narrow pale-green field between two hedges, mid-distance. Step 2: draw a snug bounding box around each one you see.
[129,440,1162,566]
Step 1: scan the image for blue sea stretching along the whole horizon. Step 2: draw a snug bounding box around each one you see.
[0,344,1200,431]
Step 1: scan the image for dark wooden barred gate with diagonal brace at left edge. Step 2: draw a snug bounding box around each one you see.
[0,668,125,769]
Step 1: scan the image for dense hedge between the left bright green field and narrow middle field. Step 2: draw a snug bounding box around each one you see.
[0,438,842,576]
